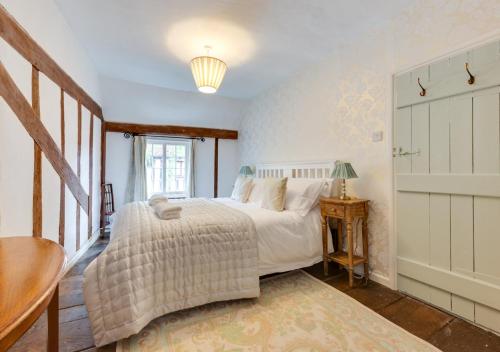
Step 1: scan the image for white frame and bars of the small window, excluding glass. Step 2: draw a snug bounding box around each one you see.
[146,137,192,199]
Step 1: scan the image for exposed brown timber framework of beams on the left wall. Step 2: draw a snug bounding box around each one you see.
[0,5,104,249]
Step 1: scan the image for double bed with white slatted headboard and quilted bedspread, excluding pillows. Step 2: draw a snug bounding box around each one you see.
[83,162,333,346]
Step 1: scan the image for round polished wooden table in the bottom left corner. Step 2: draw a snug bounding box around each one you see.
[0,237,66,352]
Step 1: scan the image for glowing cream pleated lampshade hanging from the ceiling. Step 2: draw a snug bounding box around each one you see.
[191,56,227,94]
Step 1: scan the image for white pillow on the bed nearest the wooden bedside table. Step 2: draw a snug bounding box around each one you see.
[285,178,330,216]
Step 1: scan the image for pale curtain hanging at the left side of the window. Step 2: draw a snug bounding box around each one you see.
[125,136,148,203]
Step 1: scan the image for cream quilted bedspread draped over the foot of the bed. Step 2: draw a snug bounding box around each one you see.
[83,198,260,346]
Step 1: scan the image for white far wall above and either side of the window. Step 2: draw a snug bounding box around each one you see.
[100,77,242,208]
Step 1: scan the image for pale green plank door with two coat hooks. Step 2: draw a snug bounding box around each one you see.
[394,38,500,332]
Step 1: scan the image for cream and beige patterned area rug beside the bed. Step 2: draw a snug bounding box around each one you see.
[117,271,439,352]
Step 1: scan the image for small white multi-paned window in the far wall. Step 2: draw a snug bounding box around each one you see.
[146,139,191,198]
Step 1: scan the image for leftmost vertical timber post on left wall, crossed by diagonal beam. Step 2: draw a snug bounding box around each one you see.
[31,66,42,237]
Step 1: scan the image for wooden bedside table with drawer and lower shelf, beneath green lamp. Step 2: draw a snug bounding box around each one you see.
[319,198,369,287]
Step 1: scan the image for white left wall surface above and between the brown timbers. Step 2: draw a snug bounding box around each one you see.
[0,0,100,257]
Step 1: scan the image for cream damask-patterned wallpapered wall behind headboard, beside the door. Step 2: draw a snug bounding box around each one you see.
[240,0,500,280]
